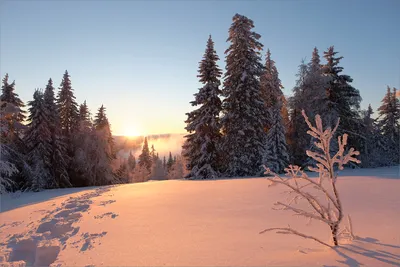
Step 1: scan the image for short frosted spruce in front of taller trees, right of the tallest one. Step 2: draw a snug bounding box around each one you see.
[263,100,289,173]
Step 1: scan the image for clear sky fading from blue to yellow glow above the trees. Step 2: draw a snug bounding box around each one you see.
[0,0,400,135]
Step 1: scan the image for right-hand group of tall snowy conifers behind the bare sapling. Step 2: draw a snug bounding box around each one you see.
[183,14,400,179]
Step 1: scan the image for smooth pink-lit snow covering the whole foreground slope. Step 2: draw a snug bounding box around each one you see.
[0,167,400,266]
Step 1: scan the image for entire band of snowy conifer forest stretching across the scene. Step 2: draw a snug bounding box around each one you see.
[0,14,400,192]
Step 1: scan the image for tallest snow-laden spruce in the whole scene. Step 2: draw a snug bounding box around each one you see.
[221,14,266,176]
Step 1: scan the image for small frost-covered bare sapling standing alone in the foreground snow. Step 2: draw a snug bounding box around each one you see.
[260,110,360,247]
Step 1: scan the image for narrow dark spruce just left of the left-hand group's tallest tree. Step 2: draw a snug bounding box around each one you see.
[43,79,71,187]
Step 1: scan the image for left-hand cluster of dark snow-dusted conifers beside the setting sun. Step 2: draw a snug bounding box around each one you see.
[0,71,126,192]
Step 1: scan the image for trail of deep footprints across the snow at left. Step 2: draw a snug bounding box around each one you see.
[0,188,114,266]
